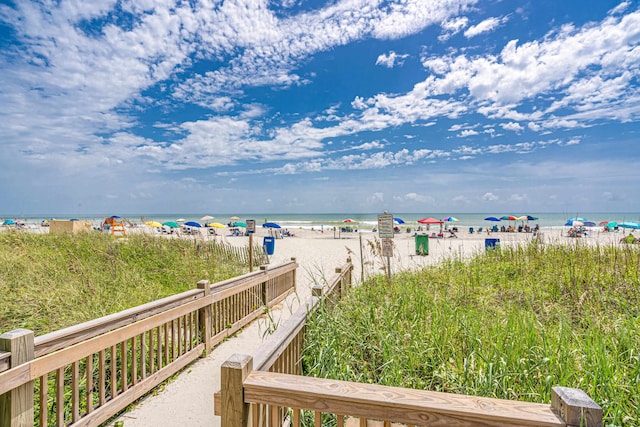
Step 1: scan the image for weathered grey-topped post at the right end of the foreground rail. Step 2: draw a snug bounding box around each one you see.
[551,386,602,427]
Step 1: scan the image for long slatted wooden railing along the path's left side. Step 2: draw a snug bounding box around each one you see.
[0,259,298,427]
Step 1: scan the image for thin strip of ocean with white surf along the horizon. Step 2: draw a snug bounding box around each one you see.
[0,212,640,230]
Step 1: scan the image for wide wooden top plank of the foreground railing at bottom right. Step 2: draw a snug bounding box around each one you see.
[242,371,565,427]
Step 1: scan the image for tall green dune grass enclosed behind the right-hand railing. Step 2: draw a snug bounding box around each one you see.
[304,244,640,425]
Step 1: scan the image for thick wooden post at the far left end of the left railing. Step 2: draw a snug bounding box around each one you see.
[0,329,34,427]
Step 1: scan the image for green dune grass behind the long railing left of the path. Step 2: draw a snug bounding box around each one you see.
[0,232,248,335]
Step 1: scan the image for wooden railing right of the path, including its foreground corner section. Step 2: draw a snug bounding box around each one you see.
[214,263,603,427]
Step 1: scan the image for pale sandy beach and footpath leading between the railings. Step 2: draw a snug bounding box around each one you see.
[96,224,625,427]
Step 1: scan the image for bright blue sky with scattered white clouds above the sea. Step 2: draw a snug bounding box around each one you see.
[0,0,640,215]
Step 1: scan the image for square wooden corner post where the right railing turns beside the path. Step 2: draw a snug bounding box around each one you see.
[220,354,253,427]
